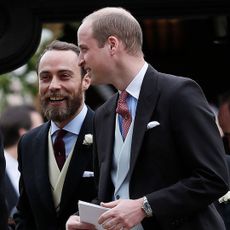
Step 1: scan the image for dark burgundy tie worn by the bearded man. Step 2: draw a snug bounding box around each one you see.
[53,129,67,170]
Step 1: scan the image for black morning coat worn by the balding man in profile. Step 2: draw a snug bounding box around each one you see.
[94,66,228,230]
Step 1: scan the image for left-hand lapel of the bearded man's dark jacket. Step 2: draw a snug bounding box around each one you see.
[33,122,55,215]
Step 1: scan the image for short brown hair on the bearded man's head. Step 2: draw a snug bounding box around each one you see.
[36,40,86,77]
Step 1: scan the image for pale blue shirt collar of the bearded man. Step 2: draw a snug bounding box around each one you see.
[51,104,88,136]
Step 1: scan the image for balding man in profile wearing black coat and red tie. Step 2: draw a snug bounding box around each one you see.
[67,7,229,230]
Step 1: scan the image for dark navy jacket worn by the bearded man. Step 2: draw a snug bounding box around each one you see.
[14,109,96,230]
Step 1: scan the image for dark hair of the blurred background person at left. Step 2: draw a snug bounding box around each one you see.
[0,105,36,147]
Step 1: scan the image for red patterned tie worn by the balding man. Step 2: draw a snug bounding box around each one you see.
[116,90,132,140]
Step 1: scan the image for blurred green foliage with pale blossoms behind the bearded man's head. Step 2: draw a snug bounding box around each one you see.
[0,22,79,113]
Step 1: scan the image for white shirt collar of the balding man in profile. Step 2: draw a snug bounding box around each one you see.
[126,62,148,100]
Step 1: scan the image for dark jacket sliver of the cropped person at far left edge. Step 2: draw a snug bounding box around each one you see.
[0,134,8,230]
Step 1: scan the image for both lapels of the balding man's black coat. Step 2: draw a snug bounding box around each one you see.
[96,66,160,200]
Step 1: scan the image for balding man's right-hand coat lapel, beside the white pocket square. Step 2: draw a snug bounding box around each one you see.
[130,66,159,175]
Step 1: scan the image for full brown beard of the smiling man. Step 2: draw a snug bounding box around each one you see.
[40,87,83,122]
